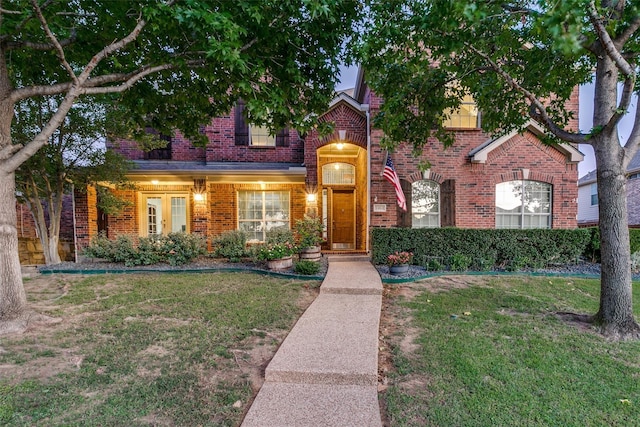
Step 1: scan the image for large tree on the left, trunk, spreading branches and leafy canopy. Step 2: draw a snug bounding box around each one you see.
[0,0,359,330]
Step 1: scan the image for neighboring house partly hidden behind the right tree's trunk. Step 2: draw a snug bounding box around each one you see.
[578,153,640,228]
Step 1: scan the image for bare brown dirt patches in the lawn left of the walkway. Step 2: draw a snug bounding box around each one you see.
[0,274,319,398]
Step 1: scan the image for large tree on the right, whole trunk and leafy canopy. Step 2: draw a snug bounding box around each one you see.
[360,0,640,338]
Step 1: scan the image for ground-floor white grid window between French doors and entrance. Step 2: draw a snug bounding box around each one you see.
[238,191,290,242]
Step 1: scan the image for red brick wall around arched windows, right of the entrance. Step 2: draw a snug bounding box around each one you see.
[364,91,578,228]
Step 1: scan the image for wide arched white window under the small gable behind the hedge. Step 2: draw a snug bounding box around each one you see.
[496,180,552,228]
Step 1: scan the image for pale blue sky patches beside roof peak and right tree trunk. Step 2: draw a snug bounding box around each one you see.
[336,66,638,177]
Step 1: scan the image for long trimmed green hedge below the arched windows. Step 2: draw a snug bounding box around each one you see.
[371,228,592,269]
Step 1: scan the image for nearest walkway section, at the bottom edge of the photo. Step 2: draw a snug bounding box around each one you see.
[242,383,382,427]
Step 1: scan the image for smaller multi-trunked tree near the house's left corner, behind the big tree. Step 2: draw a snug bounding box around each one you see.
[12,97,131,265]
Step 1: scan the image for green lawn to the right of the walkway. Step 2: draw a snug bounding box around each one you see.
[385,276,640,426]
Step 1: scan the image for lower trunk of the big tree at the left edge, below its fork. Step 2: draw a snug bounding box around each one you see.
[0,172,27,321]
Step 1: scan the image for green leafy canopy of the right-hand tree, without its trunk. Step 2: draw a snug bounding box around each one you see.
[358,0,640,151]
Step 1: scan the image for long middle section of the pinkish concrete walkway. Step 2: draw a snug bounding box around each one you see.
[265,294,382,385]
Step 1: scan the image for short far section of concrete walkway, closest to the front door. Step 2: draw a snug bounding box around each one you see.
[320,261,382,296]
